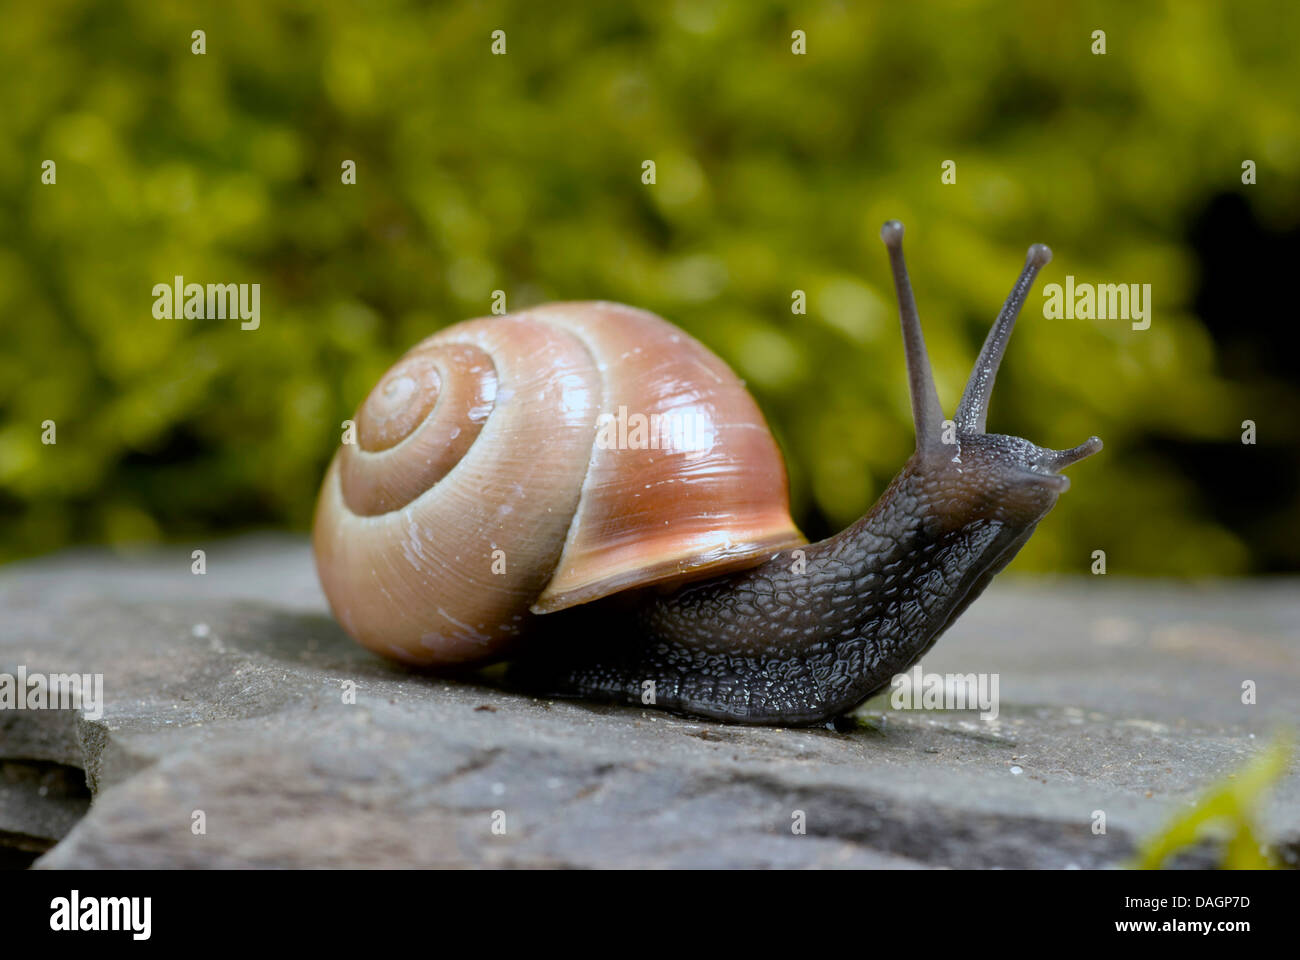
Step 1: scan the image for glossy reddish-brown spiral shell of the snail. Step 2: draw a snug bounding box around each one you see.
[313,303,803,666]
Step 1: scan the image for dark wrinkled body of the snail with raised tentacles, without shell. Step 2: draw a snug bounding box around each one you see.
[507,221,1101,726]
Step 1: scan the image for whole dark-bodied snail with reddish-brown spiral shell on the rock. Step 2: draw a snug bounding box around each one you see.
[313,221,1101,726]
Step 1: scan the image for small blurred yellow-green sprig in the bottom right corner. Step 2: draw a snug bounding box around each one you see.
[1134,734,1291,870]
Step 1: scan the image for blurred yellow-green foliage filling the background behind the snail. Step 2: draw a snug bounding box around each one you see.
[0,0,1300,574]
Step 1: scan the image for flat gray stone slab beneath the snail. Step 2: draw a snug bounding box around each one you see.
[0,537,1300,868]
